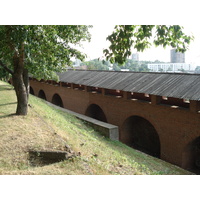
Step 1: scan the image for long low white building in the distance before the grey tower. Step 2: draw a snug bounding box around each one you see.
[148,63,191,72]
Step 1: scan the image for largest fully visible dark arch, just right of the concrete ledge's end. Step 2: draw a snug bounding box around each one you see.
[120,115,161,158]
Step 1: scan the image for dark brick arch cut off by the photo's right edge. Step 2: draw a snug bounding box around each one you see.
[182,136,200,174]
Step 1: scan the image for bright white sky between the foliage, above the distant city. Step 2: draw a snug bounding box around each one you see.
[80,24,200,69]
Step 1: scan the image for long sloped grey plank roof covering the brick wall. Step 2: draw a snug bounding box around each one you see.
[59,70,200,100]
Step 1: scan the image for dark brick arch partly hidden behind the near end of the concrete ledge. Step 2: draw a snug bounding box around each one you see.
[85,104,107,122]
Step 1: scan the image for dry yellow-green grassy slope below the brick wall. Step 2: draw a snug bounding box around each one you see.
[0,81,190,175]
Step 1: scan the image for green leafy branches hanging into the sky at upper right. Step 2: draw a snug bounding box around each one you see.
[104,25,193,64]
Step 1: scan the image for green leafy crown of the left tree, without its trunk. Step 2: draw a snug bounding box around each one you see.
[0,25,90,79]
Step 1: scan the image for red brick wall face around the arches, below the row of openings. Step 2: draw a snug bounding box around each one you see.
[30,80,200,168]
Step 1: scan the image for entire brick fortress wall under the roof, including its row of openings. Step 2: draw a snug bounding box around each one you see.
[30,79,200,172]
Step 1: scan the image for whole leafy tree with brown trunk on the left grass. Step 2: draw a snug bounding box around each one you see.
[0,25,90,115]
